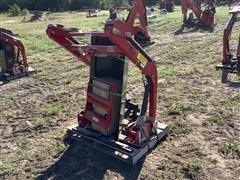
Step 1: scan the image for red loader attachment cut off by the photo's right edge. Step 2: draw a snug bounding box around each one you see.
[216,6,240,83]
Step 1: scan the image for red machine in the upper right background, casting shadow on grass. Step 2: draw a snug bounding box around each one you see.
[182,0,216,27]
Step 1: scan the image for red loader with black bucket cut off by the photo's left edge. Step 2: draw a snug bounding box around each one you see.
[0,28,32,81]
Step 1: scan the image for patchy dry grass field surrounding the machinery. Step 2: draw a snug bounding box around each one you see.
[0,7,240,180]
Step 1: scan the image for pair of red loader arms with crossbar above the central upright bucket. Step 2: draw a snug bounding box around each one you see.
[47,20,158,119]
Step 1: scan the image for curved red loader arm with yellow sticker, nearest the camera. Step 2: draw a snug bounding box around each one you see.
[108,21,158,119]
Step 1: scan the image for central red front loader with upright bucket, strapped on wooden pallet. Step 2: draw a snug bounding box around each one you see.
[47,7,169,164]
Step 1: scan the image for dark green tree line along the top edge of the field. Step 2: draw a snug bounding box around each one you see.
[0,0,158,11]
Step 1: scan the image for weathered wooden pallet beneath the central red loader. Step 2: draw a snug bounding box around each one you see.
[67,123,169,165]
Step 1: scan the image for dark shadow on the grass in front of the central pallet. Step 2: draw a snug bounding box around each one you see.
[37,141,145,180]
